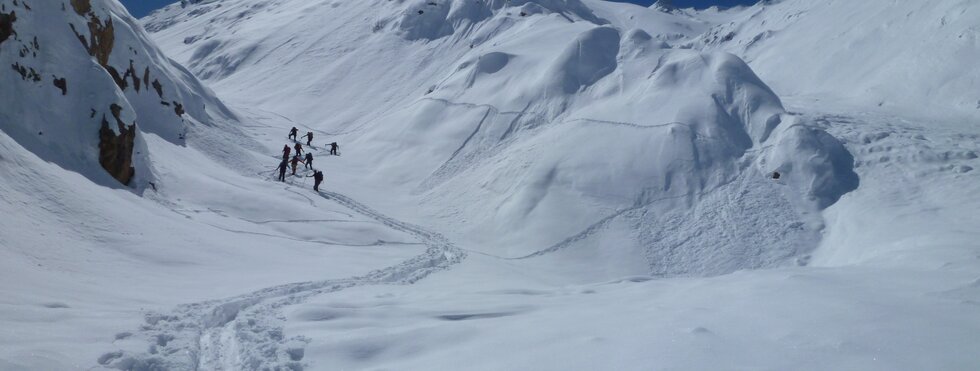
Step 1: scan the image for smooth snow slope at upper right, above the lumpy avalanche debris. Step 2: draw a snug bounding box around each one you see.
[689,0,980,118]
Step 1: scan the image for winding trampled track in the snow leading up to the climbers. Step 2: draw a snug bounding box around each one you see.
[98,191,466,371]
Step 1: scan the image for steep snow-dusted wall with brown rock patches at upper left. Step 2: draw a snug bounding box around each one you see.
[0,0,231,189]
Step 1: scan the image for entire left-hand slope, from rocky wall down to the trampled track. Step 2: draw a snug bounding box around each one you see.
[0,0,444,371]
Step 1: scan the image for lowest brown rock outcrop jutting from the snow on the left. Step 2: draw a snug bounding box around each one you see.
[99,109,136,185]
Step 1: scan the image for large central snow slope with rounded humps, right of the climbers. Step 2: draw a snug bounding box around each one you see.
[144,0,857,276]
